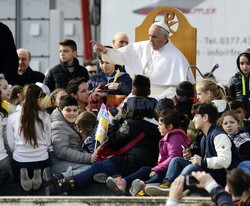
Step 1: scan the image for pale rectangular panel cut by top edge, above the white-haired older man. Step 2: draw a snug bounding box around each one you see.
[21,0,50,19]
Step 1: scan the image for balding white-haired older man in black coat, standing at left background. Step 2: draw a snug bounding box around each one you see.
[16,48,44,86]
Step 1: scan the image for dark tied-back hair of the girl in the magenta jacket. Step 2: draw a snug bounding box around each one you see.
[159,112,190,130]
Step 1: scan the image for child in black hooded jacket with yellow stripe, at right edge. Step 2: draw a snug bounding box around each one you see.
[228,49,250,118]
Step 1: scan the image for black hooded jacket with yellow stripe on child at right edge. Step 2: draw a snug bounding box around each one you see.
[228,49,250,113]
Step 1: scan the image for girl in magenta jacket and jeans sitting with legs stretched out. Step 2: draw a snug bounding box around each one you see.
[107,112,190,196]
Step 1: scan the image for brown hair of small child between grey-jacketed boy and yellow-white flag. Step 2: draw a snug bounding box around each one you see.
[75,111,97,134]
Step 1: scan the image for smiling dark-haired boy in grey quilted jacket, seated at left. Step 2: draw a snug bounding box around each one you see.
[51,96,97,173]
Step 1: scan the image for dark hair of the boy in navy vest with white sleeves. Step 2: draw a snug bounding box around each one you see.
[192,103,219,124]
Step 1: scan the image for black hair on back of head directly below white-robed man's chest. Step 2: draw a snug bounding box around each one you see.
[132,74,150,97]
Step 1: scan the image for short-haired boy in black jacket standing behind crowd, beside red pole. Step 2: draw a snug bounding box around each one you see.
[43,39,89,92]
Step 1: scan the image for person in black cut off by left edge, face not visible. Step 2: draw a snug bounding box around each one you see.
[0,22,18,85]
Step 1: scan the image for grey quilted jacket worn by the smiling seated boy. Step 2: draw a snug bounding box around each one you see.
[51,108,91,172]
